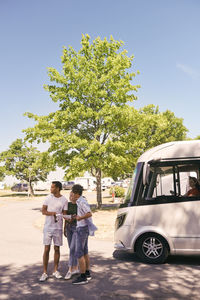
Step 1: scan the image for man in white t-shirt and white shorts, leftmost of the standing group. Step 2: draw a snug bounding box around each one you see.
[40,181,68,281]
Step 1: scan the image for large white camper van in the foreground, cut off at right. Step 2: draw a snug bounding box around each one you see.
[115,140,200,263]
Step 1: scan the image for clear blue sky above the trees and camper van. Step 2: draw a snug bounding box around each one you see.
[0,0,200,151]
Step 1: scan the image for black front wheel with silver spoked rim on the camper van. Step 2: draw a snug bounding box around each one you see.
[136,232,169,264]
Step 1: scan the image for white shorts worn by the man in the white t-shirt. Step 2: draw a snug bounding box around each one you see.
[43,229,63,246]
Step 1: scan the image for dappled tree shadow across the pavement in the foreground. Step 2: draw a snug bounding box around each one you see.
[0,251,200,300]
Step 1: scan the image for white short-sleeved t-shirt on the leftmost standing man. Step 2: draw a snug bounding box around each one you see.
[43,194,68,231]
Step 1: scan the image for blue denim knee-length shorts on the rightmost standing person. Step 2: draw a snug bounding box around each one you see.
[76,226,89,258]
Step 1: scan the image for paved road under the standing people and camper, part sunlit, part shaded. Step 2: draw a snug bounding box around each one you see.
[0,199,200,300]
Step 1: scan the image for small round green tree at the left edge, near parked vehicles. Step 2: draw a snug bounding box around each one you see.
[0,139,54,195]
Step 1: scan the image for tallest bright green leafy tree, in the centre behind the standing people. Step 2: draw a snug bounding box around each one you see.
[26,35,138,207]
